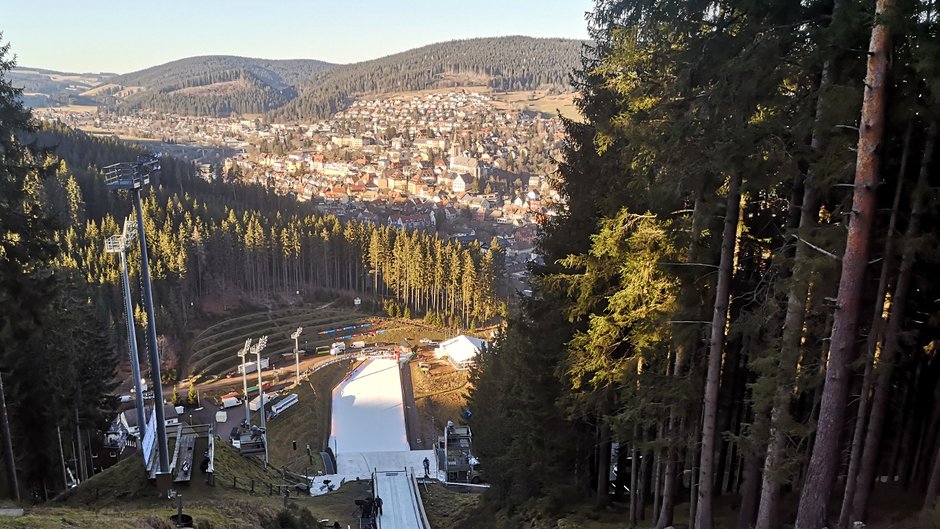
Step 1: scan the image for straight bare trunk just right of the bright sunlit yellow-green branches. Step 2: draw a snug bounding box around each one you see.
[695,175,741,529]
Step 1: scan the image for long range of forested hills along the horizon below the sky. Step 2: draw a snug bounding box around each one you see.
[14,36,582,121]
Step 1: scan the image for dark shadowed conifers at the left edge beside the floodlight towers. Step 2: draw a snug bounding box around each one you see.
[0,43,117,500]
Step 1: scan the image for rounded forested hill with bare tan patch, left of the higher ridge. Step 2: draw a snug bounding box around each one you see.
[87,55,332,116]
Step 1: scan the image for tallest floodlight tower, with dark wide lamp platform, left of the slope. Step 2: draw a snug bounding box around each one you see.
[104,154,170,474]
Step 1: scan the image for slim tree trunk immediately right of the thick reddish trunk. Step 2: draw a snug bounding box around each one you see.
[838,123,913,529]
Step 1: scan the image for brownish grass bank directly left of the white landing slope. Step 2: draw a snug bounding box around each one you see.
[268,356,352,474]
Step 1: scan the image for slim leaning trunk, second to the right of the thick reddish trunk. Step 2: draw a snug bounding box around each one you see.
[852,122,937,521]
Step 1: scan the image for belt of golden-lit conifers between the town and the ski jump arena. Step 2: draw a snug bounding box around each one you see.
[36,121,503,346]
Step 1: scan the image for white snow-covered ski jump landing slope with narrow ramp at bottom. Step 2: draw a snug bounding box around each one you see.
[311,359,436,529]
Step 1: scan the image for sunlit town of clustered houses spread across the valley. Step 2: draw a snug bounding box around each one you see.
[37,90,564,288]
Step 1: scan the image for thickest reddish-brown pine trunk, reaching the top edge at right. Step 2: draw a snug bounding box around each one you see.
[796,0,894,529]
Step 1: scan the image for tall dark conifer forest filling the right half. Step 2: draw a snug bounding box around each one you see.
[471,0,940,529]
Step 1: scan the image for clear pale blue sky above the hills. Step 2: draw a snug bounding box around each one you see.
[0,0,593,73]
